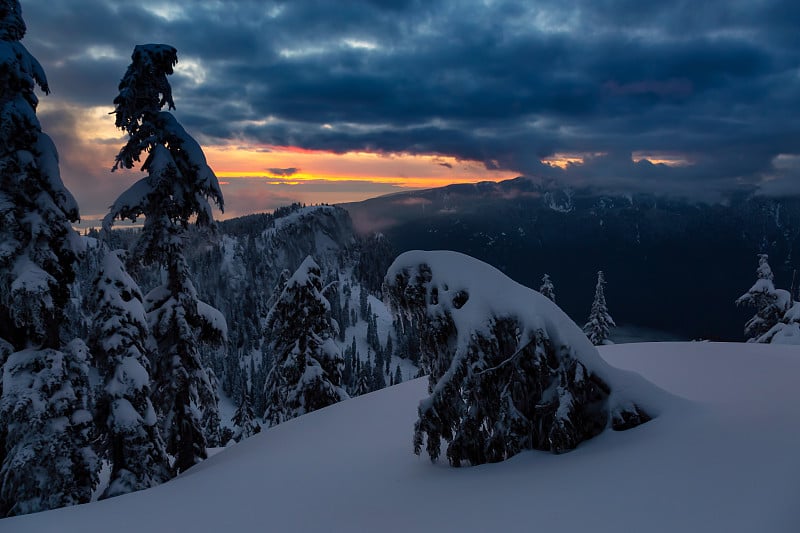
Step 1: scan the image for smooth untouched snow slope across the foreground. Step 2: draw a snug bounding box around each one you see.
[6,343,800,533]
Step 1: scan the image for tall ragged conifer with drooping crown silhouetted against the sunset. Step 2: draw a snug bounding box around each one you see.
[104,44,227,472]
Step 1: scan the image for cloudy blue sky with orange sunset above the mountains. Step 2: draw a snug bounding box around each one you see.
[17,0,800,218]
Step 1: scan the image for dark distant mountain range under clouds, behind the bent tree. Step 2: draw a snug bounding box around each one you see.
[342,178,800,341]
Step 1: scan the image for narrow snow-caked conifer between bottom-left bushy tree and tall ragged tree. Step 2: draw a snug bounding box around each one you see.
[89,251,172,497]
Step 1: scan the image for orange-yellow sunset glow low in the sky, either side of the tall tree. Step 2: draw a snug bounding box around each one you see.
[45,100,518,219]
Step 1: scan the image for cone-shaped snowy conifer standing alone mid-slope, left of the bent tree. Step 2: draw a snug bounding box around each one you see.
[265,256,348,425]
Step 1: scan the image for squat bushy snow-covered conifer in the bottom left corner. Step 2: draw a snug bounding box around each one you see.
[0,339,99,516]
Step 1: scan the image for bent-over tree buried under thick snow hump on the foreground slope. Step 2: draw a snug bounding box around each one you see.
[384,252,659,466]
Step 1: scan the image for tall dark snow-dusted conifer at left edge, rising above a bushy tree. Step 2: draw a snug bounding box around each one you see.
[0,0,80,350]
